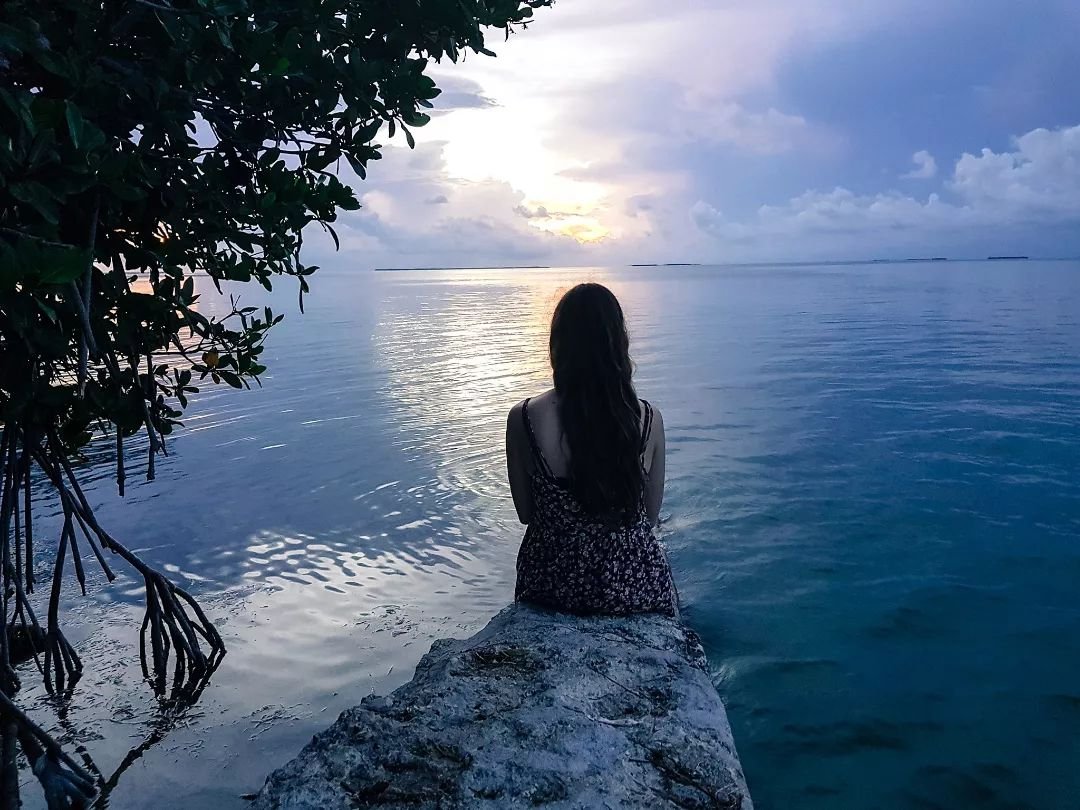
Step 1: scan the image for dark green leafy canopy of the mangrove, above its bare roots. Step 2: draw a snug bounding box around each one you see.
[0,0,550,448]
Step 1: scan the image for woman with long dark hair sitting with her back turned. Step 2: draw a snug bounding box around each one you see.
[507,284,678,616]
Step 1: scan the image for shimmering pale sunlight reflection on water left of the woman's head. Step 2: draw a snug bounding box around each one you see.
[373,271,603,498]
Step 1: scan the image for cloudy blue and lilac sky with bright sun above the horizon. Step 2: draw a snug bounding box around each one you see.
[308,0,1080,267]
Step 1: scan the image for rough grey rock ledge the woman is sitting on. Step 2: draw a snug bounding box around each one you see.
[254,606,753,810]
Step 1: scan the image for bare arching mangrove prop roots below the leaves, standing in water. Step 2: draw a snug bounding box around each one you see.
[0,438,225,807]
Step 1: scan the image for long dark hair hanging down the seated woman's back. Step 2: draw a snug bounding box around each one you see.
[550,284,645,519]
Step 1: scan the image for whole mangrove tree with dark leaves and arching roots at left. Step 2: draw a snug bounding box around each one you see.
[0,0,552,807]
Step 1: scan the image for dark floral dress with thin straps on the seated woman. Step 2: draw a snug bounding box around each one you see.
[514,400,678,616]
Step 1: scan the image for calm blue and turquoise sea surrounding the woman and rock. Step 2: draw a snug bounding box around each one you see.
[16,262,1080,810]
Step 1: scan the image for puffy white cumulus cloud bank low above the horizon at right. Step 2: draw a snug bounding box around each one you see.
[689,126,1080,249]
